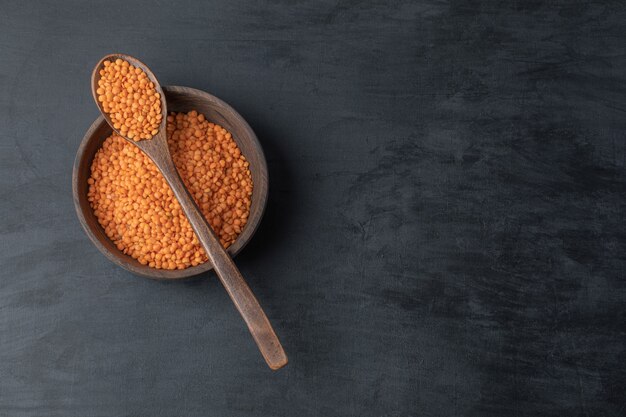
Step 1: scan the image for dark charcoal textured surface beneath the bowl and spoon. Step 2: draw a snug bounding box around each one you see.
[0,0,626,417]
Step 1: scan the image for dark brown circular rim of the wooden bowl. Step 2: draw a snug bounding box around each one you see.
[72,85,269,280]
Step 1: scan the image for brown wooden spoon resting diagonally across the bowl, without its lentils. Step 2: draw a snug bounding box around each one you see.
[91,54,287,370]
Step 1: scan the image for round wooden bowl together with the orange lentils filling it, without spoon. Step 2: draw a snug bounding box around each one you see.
[73,87,267,278]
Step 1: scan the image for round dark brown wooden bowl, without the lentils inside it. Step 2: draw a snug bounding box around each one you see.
[72,86,268,279]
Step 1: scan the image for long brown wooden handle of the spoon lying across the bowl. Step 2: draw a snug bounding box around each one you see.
[153,150,287,370]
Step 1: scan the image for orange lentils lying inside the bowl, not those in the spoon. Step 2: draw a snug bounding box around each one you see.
[88,111,252,269]
